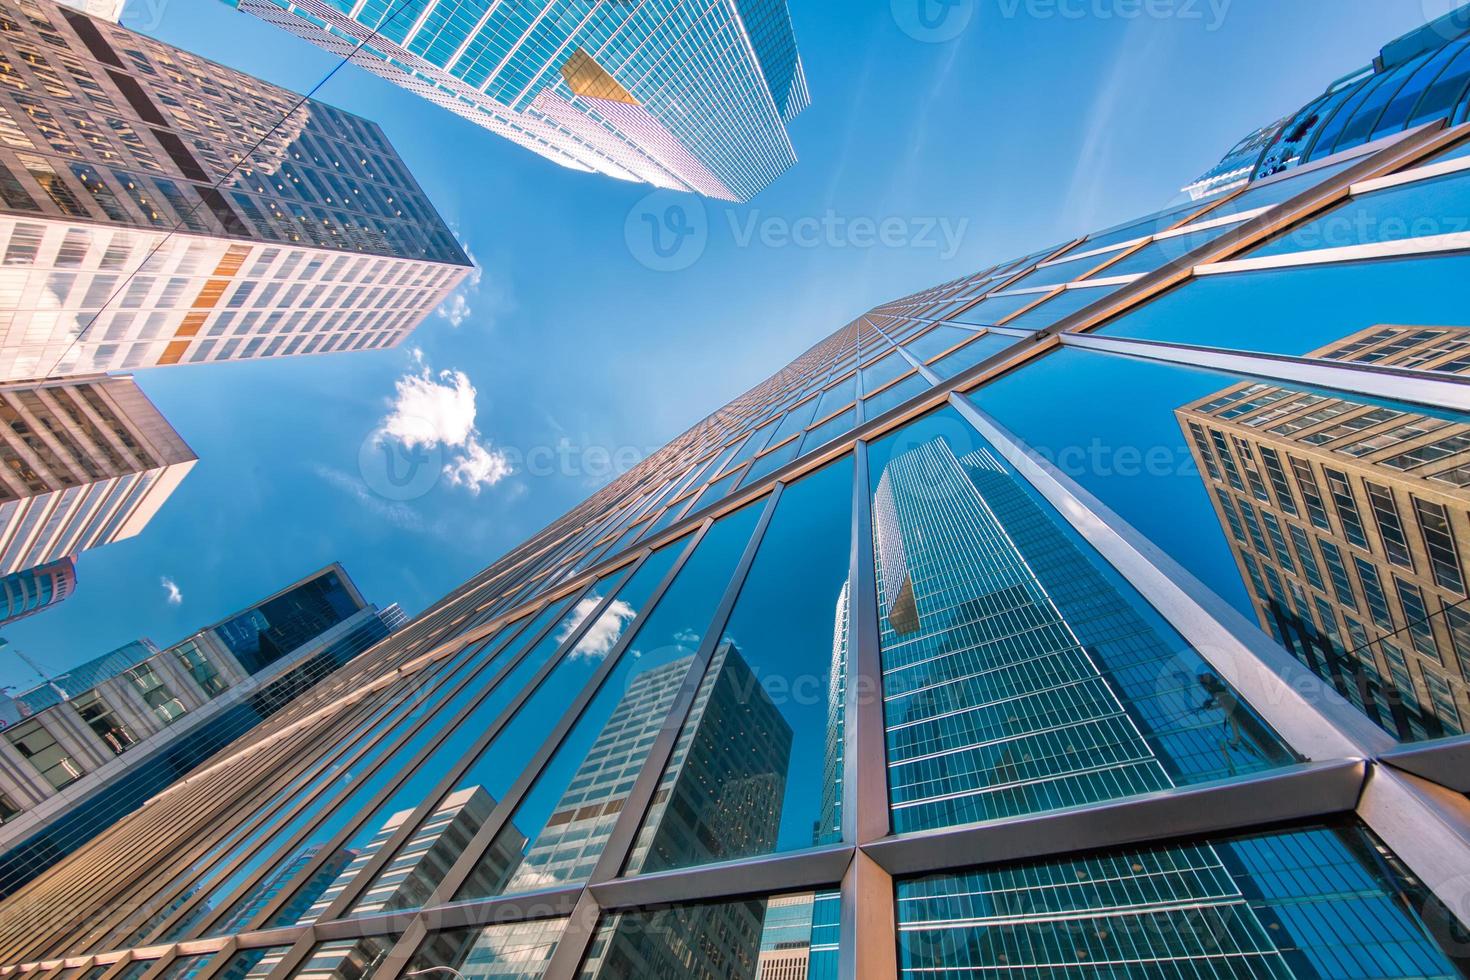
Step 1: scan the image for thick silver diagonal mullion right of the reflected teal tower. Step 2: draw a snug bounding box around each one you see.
[950,392,1394,760]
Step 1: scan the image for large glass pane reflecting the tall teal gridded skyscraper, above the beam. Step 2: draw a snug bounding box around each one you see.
[869,407,1291,833]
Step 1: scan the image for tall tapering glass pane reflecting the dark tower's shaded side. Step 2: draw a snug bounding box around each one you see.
[625,457,853,874]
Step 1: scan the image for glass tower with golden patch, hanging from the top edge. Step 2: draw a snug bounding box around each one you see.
[226,0,810,201]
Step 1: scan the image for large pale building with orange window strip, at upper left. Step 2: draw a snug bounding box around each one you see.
[0,0,470,379]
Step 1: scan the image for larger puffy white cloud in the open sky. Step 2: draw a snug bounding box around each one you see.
[376,358,515,494]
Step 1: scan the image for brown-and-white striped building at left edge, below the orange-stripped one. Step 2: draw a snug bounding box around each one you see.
[0,373,198,574]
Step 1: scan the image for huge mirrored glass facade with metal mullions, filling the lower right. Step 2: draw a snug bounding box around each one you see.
[0,7,1470,980]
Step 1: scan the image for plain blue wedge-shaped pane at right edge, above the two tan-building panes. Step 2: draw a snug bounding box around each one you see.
[1250,172,1470,257]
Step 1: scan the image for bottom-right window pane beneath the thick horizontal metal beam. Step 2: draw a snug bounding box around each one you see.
[898,823,1467,980]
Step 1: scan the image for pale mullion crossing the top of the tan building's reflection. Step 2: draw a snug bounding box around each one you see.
[1060,334,1470,411]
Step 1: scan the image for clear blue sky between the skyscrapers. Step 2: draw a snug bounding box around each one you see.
[0,0,1455,686]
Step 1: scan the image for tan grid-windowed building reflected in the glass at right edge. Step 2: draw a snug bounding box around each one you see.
[1175,326,1470,741]
